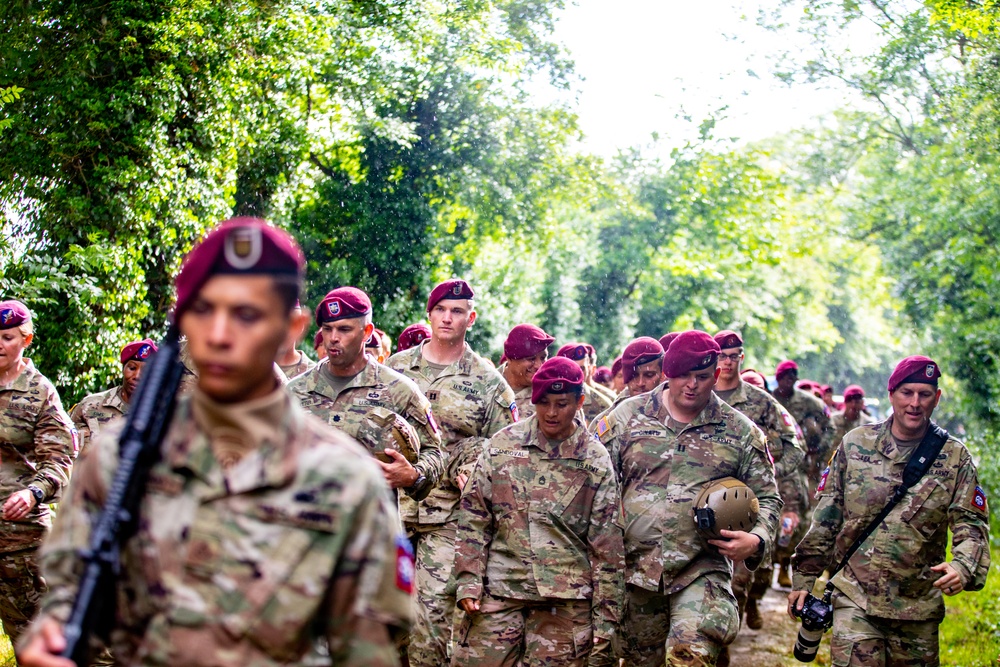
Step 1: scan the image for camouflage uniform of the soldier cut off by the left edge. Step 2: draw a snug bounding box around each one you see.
[0,359,76,642]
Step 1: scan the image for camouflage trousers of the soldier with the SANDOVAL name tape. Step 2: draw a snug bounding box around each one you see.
[451,594,593,667]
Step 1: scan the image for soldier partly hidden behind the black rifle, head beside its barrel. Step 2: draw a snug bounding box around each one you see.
[69,338,156,456]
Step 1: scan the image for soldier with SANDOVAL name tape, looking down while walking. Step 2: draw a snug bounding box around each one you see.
[452,357,625,667]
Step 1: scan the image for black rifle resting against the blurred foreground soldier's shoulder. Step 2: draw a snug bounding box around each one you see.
[62,324,184,667]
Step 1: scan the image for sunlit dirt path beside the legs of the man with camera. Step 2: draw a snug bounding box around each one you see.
[729,588,830,667]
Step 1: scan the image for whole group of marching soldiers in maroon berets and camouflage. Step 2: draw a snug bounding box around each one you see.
[0,218,989,667]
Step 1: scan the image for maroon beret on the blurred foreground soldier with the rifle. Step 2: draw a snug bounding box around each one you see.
[174,218,306,319]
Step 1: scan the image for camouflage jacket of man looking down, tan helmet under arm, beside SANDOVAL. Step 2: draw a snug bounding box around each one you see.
[594,383,781,594]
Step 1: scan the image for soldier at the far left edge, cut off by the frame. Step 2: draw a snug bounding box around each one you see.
[0,300,76,643]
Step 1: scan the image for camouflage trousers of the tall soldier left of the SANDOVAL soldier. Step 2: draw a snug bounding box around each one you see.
[407,523,462,667]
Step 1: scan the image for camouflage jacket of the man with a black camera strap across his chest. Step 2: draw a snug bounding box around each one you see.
[792,419,990,621]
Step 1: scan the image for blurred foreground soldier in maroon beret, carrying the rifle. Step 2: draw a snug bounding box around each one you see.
[19,218,412,667]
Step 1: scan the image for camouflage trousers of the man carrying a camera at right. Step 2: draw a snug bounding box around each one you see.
[830,595,941,667]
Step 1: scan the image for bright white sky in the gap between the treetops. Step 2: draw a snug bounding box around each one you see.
[555,0,868,156]
